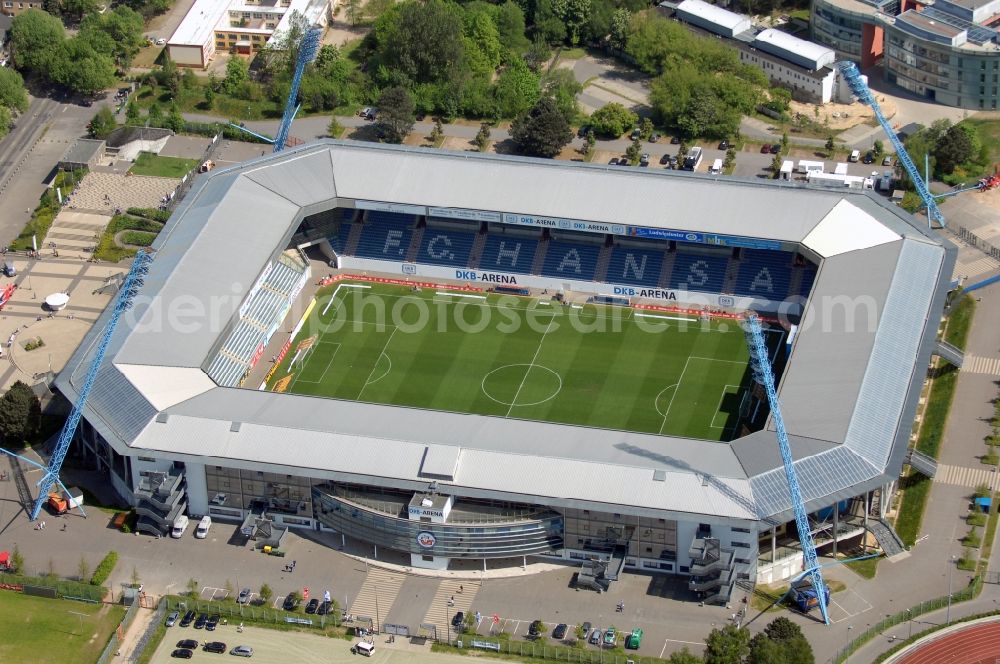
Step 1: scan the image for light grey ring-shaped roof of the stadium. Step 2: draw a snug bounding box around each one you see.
[57,141,954,519]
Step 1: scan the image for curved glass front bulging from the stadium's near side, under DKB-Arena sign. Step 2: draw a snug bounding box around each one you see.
[312,484,563,558]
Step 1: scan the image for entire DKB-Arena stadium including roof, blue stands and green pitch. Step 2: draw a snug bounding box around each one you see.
[56,141,955,603]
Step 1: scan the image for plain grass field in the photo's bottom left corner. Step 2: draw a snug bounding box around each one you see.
[0,591,125,664]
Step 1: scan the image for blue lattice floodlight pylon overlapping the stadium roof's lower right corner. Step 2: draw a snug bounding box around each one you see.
[743,312,830,625]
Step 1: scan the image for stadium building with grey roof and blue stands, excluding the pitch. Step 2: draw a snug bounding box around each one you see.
[56,141,955,601]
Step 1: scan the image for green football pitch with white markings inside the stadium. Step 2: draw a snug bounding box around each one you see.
[267,282,773,440]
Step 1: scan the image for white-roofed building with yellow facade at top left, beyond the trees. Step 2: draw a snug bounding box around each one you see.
[167,0,331,68]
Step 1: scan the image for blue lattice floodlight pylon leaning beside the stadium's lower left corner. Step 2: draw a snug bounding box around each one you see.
[31,250,153,521]
